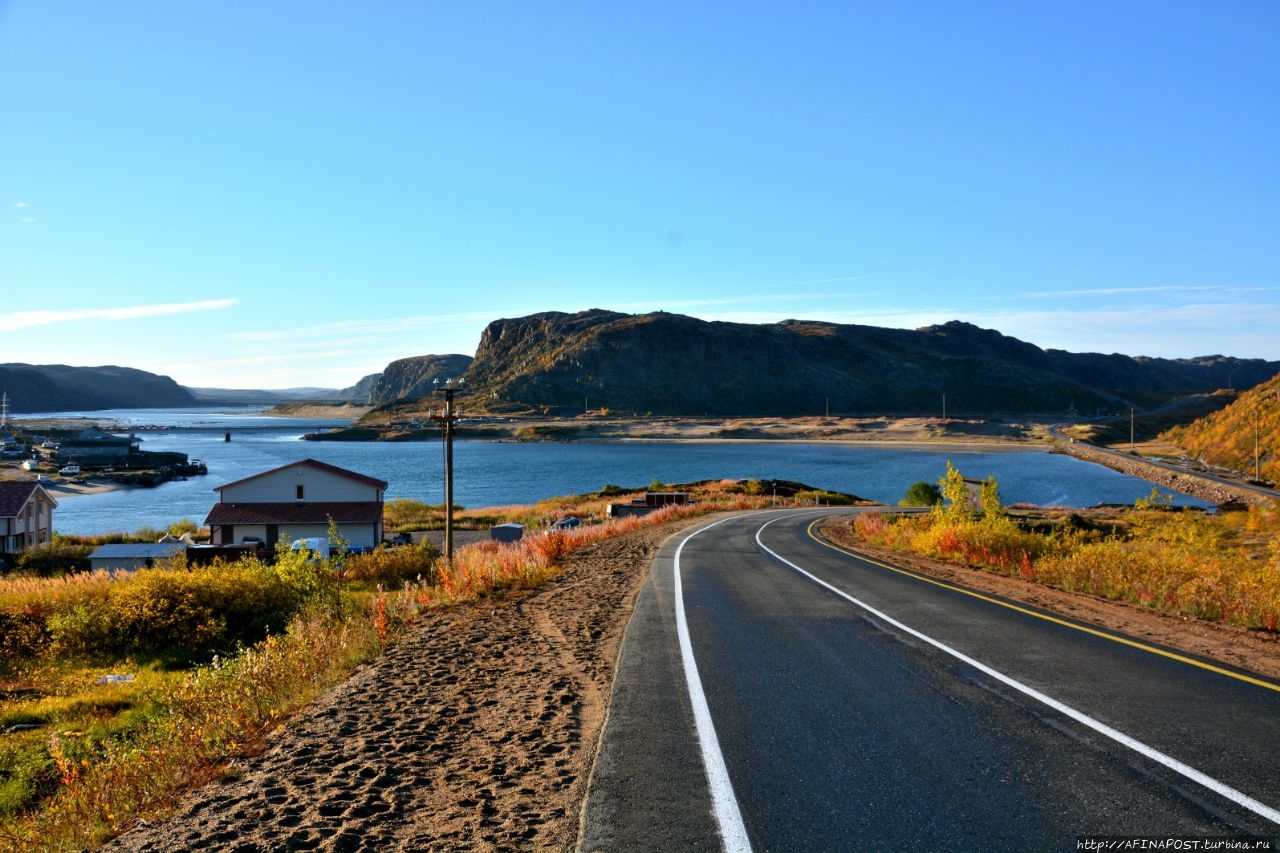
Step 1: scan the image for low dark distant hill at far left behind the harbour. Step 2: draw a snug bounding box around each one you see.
[0,364,196,412]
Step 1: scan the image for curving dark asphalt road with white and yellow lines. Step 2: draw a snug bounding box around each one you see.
[580,510,1280,850]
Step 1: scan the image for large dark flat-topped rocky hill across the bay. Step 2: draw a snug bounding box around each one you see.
[450,310,1280,416]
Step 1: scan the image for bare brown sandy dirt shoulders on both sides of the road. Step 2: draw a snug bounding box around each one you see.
[99,507,1280,853]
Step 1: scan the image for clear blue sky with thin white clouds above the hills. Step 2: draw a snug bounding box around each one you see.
[0,0,1280,388]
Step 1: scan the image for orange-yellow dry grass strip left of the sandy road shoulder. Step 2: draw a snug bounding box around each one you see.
[0,488,767,850]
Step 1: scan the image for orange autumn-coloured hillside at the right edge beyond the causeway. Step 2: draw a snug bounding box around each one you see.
[1160,375,1280,483]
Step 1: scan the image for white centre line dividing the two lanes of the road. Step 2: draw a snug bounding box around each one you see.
[755,519,1280,824]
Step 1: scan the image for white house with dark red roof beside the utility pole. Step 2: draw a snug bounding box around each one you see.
[205,459,387,548]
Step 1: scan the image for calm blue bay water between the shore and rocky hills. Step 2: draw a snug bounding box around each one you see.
[15,410,1207,534]
